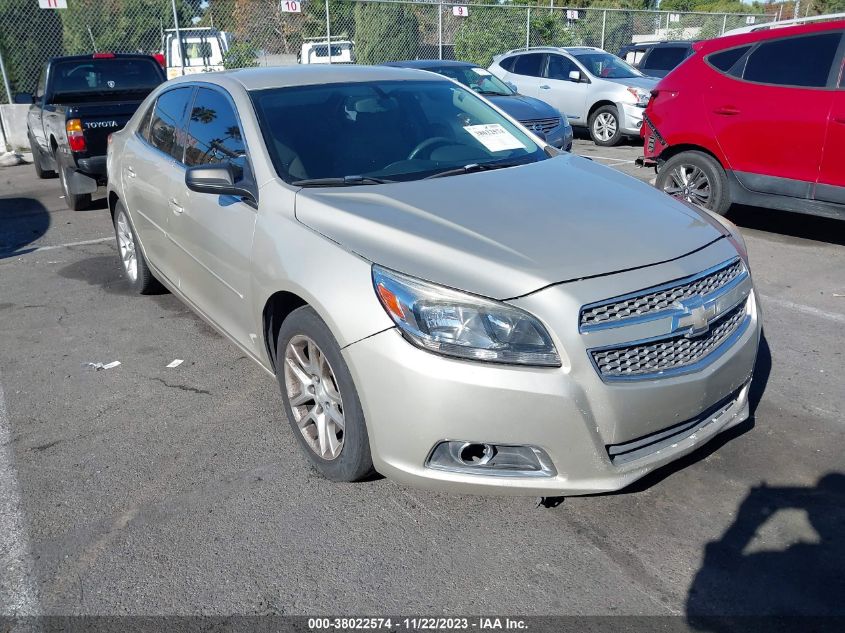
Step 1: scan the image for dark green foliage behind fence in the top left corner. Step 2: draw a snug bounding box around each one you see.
[0,0,62,95]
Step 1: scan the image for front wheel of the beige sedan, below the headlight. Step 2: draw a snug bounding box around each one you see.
[276,306,374,482]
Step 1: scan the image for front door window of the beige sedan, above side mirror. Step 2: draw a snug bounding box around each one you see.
[185,88,246,168]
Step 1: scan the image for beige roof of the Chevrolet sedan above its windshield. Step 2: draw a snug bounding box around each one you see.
[168,64,449,90]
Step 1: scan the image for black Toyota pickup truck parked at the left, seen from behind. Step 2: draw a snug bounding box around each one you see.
[15,53,166,210]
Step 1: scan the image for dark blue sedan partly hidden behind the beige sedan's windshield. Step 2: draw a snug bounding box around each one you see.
[385,59,572,152]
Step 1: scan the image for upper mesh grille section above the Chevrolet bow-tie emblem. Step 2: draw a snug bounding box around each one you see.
[580,259,745,331]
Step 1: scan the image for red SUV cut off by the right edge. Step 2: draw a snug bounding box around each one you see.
[638,20,845,219]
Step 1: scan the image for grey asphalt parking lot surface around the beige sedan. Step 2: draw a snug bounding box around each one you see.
[0,140,845,630]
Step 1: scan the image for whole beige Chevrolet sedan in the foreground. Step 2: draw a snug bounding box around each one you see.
[108,66,760,495]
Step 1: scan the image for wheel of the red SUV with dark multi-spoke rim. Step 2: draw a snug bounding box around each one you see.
[654,151,731,215]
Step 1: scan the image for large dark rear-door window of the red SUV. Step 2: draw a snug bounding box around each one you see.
[742,33,842,88]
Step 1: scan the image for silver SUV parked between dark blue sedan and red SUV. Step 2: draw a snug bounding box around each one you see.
[488,46,659,146]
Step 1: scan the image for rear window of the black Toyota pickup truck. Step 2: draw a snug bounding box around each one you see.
[51,58,164,103]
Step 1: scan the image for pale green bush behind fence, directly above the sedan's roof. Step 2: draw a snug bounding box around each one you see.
[355,2,419,64]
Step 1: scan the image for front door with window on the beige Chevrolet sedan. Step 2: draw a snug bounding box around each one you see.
[170,87,256,346]
